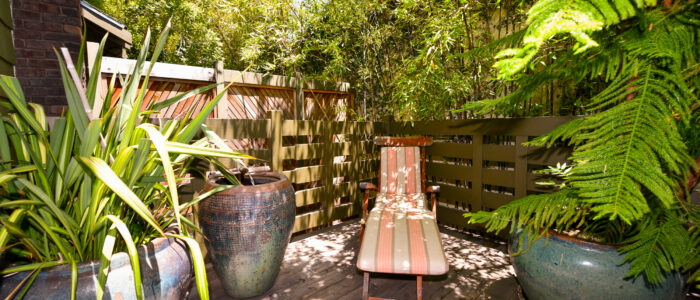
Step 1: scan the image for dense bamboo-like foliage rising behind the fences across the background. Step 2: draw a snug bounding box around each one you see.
[90,0,544,120]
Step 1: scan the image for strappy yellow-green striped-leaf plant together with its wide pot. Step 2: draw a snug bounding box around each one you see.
[0,23,246,299]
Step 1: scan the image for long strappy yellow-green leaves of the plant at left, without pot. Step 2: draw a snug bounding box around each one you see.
[0,25,252,299]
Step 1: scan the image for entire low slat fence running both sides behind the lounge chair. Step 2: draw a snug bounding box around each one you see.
[206,111,573,232]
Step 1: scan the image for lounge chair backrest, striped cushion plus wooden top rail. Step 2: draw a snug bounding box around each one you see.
[374,137,433,194]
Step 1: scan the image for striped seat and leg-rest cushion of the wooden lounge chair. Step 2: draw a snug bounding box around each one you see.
[357,193,448,275]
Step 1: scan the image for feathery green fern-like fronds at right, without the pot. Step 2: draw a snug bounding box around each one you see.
[467,0,700,283]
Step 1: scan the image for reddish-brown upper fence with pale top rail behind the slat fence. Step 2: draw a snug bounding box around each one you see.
[93,54,353,120]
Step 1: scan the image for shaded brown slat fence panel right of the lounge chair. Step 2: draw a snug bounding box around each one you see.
[377,117,575,229]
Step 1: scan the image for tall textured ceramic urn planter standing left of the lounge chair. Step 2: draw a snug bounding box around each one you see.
[198,173,296,298]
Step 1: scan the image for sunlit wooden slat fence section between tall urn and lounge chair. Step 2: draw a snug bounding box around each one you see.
[206,111,378,232]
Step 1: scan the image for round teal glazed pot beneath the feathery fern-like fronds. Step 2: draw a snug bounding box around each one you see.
[508,231,685,300]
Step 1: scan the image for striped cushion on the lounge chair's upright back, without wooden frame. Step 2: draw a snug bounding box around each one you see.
[379,147,422,194]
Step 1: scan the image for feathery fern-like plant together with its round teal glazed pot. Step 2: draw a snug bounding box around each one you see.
[465,0,700,299]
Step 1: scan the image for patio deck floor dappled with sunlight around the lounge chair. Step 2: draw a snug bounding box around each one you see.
[189,220,518,300]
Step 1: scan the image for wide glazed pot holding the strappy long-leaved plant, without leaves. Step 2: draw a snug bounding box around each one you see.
[0,238,194,300]
